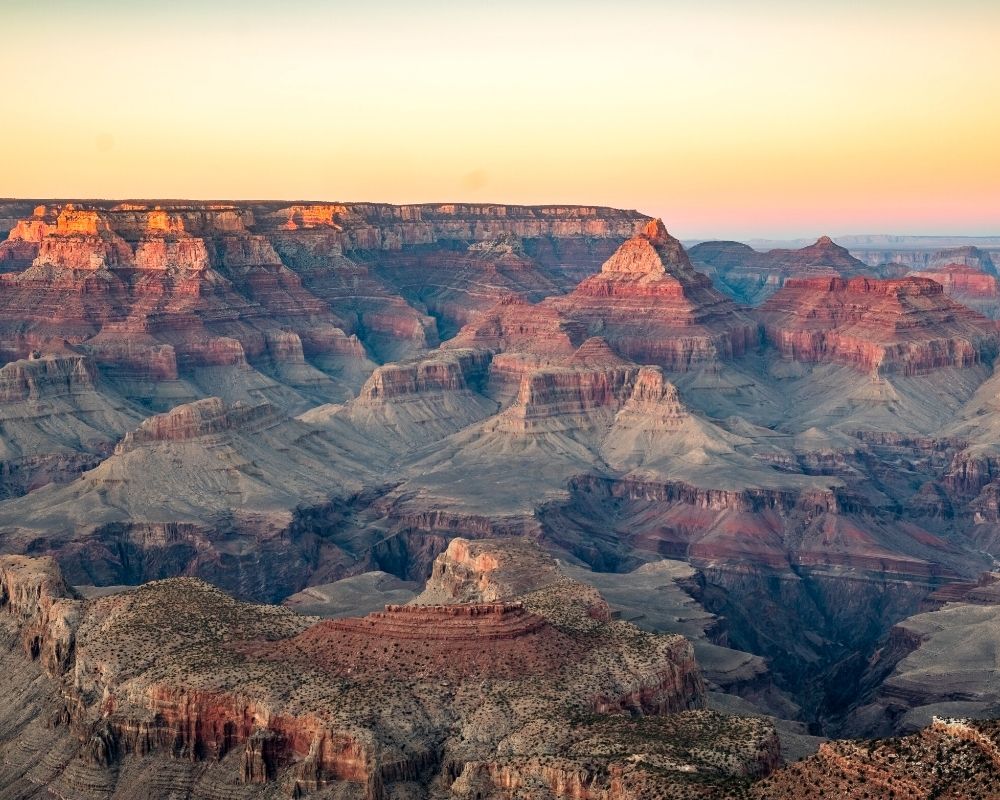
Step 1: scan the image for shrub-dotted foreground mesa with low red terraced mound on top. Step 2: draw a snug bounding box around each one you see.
[0,558,744,800]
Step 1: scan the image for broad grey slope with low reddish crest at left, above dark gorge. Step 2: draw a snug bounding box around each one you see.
[0,398,378,598]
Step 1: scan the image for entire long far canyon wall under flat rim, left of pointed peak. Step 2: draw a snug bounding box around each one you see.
[0,202,644,410]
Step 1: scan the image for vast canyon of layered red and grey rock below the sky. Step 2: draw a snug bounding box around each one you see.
[0,200,1000,800]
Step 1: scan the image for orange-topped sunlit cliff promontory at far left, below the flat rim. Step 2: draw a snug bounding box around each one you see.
[0,204,370,412]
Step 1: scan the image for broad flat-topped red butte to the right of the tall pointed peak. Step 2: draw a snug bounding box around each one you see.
[758,278,998,375]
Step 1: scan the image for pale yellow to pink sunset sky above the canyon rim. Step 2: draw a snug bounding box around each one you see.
[0,0,1000,238]
